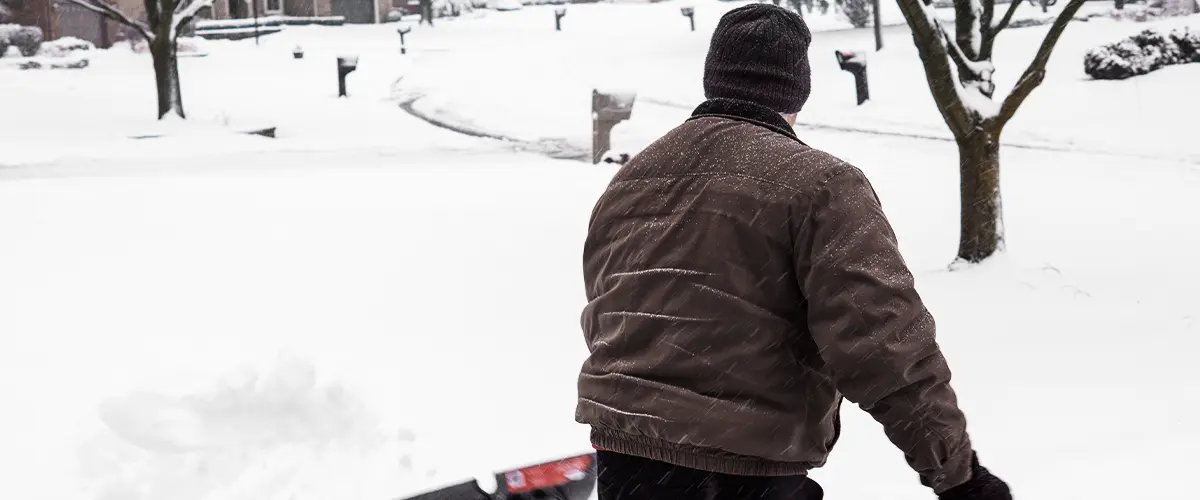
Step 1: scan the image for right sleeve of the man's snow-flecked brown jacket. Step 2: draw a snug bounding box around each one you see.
[796,165,972,493]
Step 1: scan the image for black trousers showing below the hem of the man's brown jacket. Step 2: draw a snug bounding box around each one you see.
[596,450,824,500]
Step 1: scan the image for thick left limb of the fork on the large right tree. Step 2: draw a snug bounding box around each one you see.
[896,0,973,137]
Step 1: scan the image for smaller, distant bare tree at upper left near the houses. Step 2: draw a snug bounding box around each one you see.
[66,0,212,120]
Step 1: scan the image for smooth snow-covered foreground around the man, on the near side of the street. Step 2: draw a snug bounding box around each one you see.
[0,126,1200,500]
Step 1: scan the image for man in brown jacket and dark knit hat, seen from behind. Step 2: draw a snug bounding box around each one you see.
[576,4,1010,500]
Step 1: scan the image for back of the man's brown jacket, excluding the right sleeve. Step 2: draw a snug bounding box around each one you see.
[580,102,852,475]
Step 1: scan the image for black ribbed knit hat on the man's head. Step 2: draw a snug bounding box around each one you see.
[704,4,812,113]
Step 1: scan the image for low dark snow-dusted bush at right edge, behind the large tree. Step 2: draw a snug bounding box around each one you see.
[1084,28,1200,80]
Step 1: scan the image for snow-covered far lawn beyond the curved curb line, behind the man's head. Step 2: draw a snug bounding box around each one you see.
[398,2,1200,159]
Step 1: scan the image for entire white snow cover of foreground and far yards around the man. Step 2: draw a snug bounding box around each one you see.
[0,1,1200,500]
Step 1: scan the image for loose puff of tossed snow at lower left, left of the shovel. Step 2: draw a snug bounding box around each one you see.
[78,359,413,500]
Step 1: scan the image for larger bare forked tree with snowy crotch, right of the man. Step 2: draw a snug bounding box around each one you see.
[896,0,1085,263]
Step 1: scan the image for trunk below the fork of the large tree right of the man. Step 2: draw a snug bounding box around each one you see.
[958,128,1004,263]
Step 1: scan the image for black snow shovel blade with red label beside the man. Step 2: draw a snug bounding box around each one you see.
[403,453,596,500]
